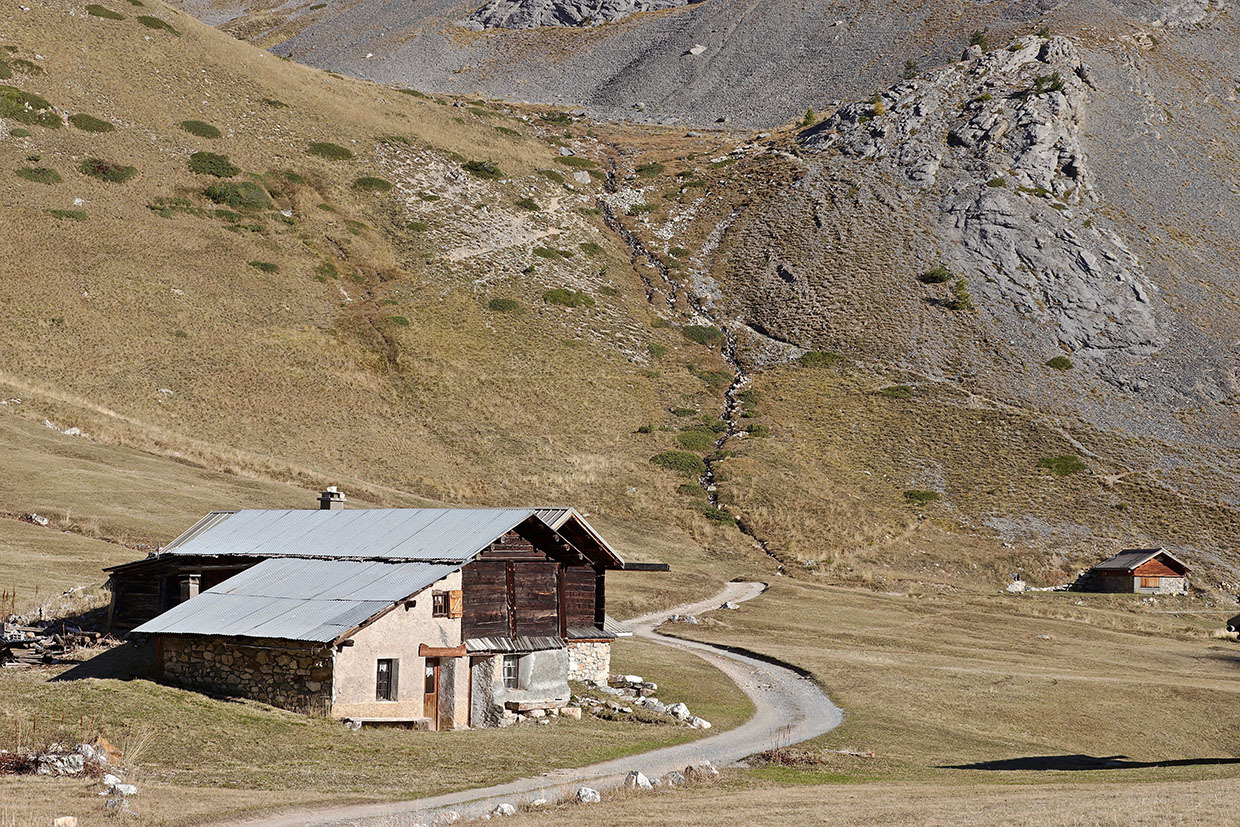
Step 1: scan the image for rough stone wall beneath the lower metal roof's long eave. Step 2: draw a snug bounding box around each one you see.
[159,635,332,715]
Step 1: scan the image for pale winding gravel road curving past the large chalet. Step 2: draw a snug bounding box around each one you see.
[217,583,843,827]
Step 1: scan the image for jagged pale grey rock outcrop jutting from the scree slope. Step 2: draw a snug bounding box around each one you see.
[802,36,1166,362]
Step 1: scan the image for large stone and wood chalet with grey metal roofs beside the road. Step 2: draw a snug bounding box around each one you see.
[107,490,667,729]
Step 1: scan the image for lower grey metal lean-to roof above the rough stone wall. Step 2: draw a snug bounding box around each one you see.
[134,560,460,643]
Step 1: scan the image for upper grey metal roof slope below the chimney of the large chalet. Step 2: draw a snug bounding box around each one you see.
[159,508,534,562]
